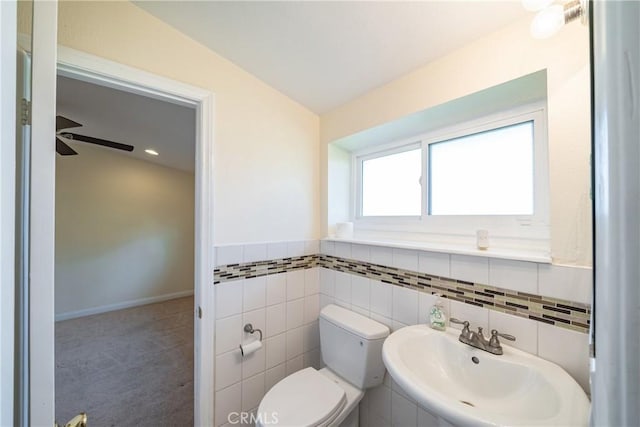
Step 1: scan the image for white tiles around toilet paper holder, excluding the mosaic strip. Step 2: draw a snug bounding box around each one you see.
[215,247,322,426]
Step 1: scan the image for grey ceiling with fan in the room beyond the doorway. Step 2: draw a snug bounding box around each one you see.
[56,76,196,172]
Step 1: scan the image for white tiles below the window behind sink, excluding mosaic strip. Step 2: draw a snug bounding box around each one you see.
[312,245,589,427]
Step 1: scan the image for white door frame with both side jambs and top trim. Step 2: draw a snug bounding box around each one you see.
[24,38,215,425]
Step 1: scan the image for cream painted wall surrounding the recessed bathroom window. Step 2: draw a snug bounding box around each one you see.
[320,16,592,266]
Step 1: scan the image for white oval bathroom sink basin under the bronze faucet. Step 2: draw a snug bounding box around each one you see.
[382,325,590,426]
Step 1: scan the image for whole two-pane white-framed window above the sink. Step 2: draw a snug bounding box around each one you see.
[352,104,548,249]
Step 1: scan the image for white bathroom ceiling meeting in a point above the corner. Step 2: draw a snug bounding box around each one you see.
[134,0,527,114]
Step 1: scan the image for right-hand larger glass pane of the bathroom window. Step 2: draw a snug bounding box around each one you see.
[427,120,534,215]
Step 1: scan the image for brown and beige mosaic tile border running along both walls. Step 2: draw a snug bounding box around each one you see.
[214,254,591,333]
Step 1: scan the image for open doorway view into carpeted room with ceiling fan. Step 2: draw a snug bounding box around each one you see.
[55,76,196,426]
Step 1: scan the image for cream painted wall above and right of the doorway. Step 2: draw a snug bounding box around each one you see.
[52,1,320,245]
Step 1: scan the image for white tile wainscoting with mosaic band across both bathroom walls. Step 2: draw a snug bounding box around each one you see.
[215,241,591,425]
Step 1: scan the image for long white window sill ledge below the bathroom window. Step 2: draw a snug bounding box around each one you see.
[322,237,551,264]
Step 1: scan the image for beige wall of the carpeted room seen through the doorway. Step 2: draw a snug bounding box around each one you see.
[55,143,195,319]
